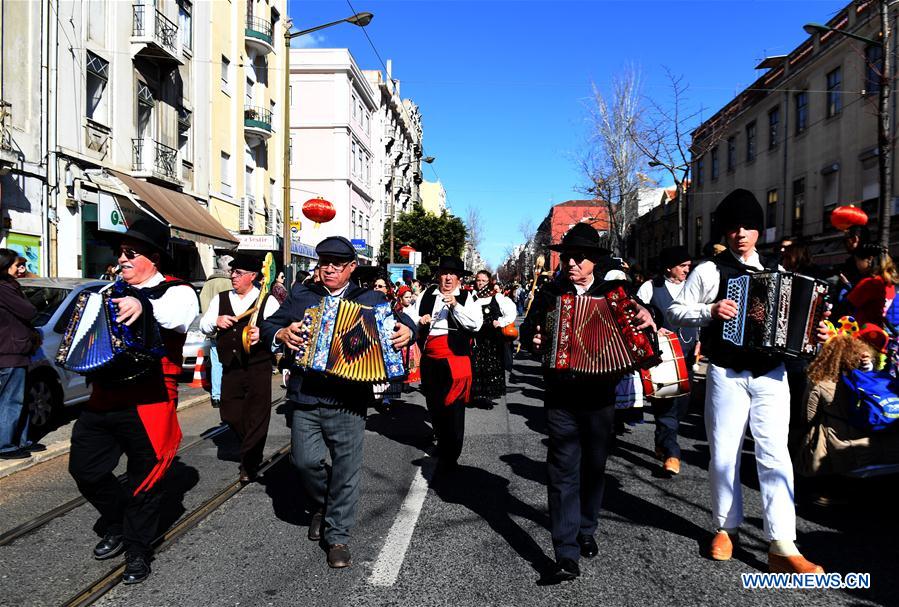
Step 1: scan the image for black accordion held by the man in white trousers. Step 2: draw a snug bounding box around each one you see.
[721,271,827,357]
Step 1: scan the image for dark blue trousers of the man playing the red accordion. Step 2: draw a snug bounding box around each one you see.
[546,402,615,561]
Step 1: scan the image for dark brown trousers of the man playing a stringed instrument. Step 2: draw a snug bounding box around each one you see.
[219,359,272,474]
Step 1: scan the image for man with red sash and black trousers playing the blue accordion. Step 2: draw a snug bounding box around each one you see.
[69,218,199,584]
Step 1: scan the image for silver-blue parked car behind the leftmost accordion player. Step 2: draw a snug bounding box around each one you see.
[19,278,109,431]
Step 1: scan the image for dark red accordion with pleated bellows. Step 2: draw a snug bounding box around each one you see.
[544,287,660,375]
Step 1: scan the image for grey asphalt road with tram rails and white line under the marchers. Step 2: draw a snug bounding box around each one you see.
[0,360,899,607]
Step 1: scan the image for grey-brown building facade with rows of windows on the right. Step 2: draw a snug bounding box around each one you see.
[687,1,896,262]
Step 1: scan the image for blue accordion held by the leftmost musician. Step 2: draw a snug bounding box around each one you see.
[56,281,165,382]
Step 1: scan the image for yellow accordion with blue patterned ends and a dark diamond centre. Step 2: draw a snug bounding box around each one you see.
[296,297,405,383]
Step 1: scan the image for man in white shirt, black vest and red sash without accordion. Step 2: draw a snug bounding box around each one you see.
[408,255,484,475]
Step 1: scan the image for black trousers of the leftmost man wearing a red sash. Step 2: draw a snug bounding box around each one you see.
[69,407,162,555]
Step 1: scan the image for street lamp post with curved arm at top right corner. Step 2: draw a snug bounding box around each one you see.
[802,5,893,250]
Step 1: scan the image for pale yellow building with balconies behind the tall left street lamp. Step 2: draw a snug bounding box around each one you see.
[208,0,288,250]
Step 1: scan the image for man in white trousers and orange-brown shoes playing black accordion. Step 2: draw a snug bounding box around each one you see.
[667,189,823,573]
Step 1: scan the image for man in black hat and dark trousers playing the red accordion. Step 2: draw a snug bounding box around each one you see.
[520,223,655,581]
